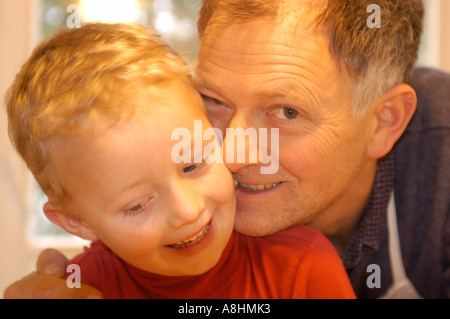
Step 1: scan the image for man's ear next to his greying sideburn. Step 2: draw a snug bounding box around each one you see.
[367,83,417,159]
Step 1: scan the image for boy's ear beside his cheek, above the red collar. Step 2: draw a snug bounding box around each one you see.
[43,202,98,241]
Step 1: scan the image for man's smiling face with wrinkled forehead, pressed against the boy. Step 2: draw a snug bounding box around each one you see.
[196,22,374,236]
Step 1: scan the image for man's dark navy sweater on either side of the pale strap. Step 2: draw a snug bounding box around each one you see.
[347,68,450,298]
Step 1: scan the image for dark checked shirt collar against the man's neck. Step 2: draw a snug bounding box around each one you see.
[342,152,395,270]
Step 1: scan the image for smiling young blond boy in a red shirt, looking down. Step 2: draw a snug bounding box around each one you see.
[6,24,354,298]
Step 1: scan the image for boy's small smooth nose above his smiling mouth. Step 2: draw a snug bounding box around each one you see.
[169,182,205,229]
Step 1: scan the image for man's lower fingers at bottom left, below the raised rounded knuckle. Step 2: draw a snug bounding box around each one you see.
[4,273,102,299]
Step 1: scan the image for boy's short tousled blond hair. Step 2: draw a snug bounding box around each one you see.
[5,23,194,205]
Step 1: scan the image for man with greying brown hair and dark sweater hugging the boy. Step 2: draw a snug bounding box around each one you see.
[7,0,450,298]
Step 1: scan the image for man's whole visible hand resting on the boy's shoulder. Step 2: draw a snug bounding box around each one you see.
[4,249,102,299]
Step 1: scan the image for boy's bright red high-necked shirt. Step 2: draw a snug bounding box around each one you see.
[69,226,355,299]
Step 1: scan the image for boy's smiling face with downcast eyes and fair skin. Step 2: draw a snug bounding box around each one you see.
[51,81,236,276]
